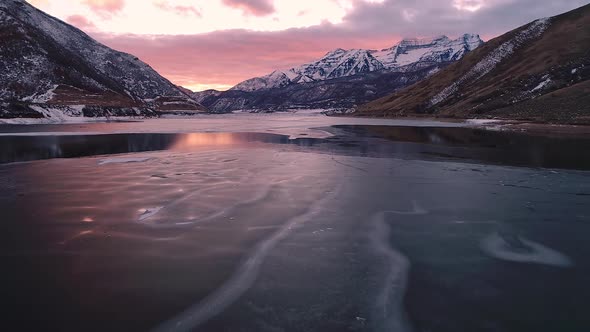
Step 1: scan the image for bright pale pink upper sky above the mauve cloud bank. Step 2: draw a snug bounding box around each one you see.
[29,0,383,35]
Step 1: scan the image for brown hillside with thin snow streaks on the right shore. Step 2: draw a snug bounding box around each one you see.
[357,5,590,123]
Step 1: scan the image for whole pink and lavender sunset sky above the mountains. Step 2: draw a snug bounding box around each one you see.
[28,0,589,91]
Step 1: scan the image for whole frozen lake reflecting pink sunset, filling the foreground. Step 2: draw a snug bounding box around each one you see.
[0,114,590,331]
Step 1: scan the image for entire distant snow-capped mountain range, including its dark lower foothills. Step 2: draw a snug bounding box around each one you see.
[194,34,483,112]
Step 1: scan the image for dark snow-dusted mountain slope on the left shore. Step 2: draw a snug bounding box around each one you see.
[0,0,204,117]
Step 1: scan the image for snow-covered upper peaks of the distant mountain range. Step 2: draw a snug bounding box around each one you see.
[232,34,483,91]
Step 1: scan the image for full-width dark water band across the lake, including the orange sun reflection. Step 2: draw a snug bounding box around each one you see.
[0,125,590,169]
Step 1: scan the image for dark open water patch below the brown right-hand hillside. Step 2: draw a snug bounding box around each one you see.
[334,125,590,169]
